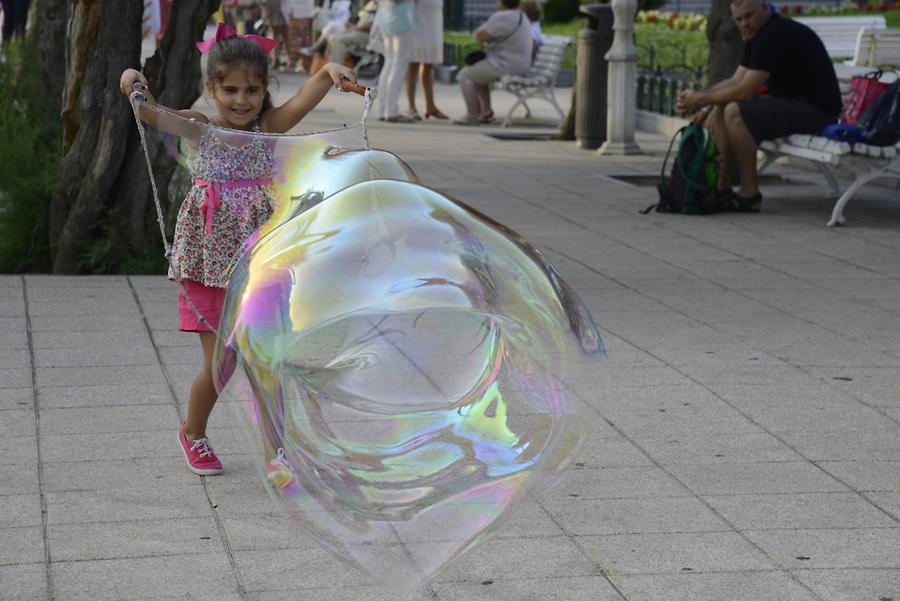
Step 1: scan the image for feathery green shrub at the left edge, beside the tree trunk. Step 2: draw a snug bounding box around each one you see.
[0,41,62,272]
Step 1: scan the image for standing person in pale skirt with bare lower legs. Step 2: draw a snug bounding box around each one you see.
[406,0,447,120]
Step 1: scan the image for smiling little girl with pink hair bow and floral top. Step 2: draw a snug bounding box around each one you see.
[119,24,355,476]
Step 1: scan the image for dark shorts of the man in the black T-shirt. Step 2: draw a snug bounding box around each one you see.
[738,94,835,144]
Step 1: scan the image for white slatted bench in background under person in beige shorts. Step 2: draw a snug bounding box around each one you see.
[494,35,572,127]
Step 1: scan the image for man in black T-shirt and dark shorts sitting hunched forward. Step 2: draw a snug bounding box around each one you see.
[677,0,841,212]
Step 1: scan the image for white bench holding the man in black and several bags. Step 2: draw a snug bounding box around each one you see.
[757,69,900,226]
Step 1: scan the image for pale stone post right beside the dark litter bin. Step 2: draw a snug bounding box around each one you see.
[598,0,641,156]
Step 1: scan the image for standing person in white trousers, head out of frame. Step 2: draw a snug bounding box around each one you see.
[375,0,416,123]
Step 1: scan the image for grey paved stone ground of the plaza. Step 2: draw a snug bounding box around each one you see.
[0,76,900,601]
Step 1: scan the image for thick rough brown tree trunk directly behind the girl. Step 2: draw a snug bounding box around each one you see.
[50,0,219,273]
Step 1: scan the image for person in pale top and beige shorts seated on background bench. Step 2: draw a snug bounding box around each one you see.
[453,0,534,125]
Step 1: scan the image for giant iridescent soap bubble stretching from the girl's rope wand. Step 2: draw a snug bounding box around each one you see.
[130,95,602,590]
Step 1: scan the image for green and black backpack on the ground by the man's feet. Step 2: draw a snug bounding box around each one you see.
[641,123,719,215]
